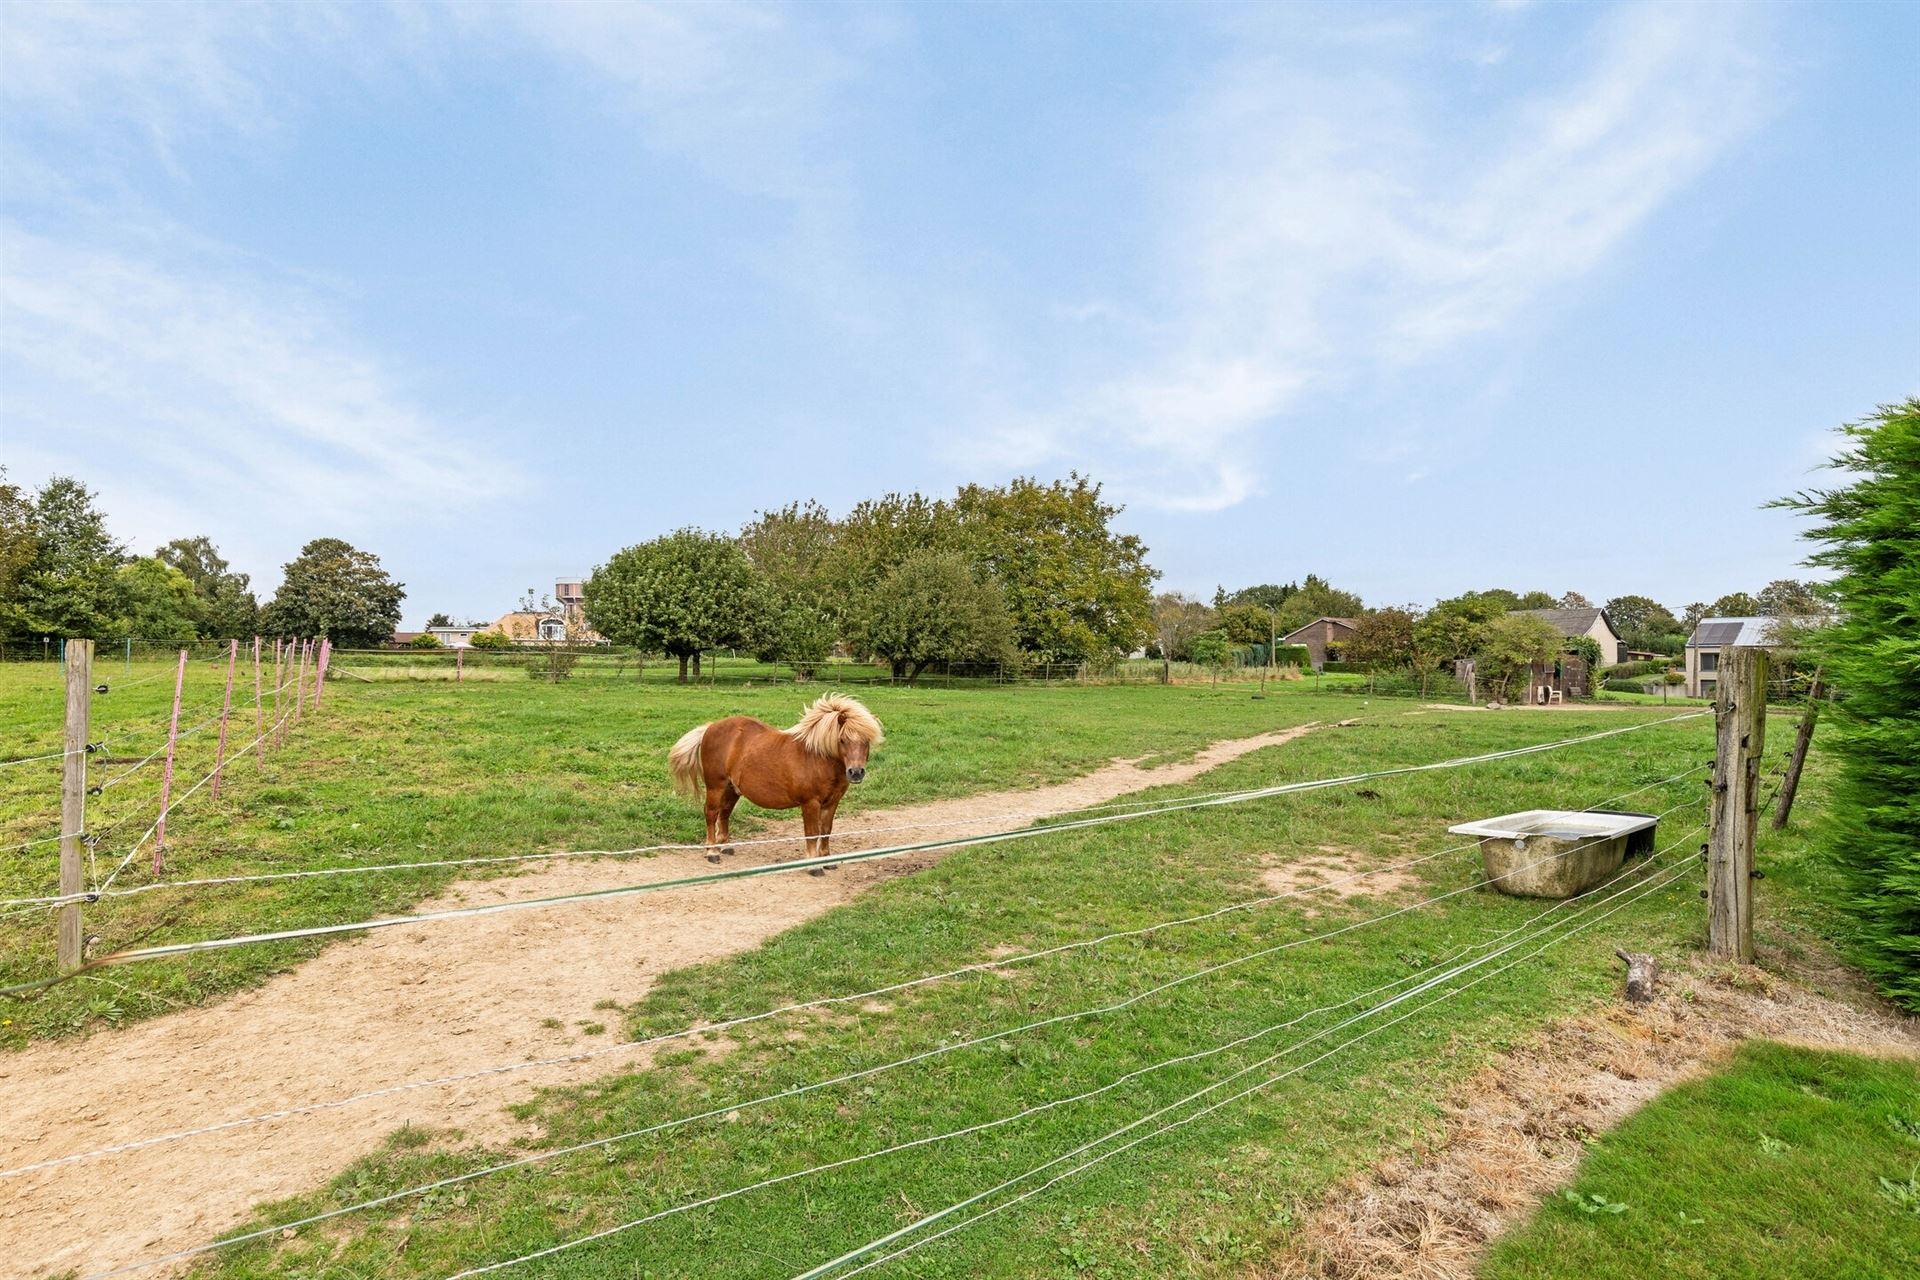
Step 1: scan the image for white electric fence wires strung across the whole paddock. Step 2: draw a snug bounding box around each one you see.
[0,651,1709,1280]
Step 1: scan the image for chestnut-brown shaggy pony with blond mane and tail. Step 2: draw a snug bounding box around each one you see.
[666,693,885,875]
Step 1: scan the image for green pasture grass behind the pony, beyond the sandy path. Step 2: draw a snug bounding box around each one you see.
[0,667,1382,1046]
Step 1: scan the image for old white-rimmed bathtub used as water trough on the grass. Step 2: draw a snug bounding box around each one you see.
[1448,810,1659,898]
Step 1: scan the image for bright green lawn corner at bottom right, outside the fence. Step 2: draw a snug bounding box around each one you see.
[1480,1044,1920,1280]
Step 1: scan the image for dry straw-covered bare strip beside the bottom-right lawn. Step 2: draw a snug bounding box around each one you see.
[1248,969,1920,1280]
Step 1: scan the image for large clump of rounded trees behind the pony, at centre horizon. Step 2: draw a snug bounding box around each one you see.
[584,474,1156,681]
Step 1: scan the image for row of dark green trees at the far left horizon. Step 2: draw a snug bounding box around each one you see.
[0,470,407,647]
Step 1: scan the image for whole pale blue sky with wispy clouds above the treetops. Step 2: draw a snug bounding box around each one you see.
[0,2,1920,624]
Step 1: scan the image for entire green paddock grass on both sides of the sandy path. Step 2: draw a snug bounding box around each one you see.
[0,672,1873,1276]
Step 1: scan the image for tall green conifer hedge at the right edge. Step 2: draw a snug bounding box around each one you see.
[1778,399,1920,1009]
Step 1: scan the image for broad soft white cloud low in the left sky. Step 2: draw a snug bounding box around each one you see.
[0,226,503,524]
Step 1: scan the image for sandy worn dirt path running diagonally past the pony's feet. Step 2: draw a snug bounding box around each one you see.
[0,725,1313,1276]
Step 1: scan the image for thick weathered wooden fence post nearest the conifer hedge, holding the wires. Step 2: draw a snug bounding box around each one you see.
[1707,649,1766,963]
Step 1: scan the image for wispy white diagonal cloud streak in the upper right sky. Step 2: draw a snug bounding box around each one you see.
[1008,6,1766,510]
